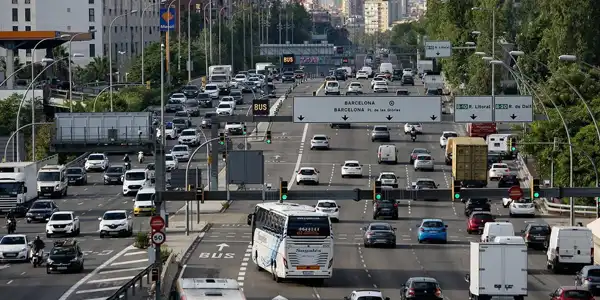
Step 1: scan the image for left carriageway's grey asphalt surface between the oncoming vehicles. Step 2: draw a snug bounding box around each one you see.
[0,84,291,300]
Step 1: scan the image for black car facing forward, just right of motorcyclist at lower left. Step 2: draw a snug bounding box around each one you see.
[46,239,85,274]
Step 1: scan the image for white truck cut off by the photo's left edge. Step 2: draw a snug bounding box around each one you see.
[0,155,58,216]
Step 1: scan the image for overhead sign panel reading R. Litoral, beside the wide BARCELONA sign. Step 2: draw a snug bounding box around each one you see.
[454,96,493,123]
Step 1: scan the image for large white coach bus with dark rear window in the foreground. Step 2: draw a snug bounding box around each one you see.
[248,202,333,282]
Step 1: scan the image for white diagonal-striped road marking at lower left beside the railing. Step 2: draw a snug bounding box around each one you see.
[68,246,150,300]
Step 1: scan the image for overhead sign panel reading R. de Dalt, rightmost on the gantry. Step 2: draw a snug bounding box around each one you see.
[494,96,533,122]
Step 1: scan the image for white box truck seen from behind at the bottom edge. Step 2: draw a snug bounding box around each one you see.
[465,242,527,300]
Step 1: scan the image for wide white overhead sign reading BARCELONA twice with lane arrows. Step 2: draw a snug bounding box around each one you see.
[294,96,442,123]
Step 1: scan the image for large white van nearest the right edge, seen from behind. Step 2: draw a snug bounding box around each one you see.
[546,226,594,273]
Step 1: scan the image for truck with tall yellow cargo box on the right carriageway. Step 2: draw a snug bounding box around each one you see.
[448,137,488,188]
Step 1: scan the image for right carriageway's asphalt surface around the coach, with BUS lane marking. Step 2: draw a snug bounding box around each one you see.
[183,80,573,300]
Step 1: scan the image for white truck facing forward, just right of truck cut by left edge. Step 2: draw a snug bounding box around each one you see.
[37,165,69,198]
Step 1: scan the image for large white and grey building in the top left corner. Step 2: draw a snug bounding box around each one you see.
[0,0,160,65]
